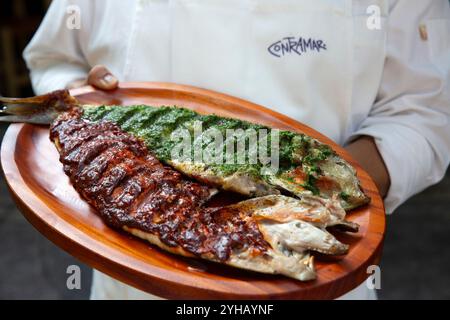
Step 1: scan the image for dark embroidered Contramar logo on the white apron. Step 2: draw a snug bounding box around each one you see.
[267,37,327,58]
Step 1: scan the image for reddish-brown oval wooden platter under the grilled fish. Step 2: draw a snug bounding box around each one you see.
[1,83,385,299]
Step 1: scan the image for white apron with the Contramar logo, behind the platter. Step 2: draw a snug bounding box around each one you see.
[92,0,387,299]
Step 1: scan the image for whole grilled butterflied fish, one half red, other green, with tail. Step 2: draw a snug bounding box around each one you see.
[0,91,368,280]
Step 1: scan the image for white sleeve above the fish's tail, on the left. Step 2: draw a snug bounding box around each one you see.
[23,0,93,94]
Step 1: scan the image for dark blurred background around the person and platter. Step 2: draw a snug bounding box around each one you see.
[0,0,450,299]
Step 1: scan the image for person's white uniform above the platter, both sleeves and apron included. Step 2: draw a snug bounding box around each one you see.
[24,0,450,300]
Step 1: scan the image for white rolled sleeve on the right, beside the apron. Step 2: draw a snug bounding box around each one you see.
[351,0,450,213]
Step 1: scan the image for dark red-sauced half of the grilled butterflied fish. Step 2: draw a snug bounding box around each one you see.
[44,108,358,281]
